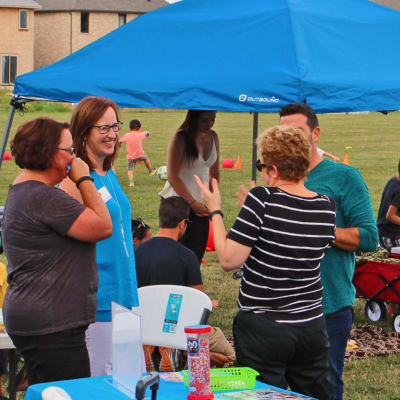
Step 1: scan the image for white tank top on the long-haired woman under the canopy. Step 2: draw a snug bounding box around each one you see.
[159,137,217,201]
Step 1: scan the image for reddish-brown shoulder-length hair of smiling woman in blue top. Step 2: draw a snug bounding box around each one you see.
[70,96,119,171]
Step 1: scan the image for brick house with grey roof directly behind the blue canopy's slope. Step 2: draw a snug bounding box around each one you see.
[32,0,169,69]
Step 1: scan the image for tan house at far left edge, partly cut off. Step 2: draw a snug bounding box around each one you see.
[0,0,41,89]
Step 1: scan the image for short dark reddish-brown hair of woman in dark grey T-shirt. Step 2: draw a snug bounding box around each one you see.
[10,118,69,171]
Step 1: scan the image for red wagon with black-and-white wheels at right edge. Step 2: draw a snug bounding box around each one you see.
[353,255,400,332]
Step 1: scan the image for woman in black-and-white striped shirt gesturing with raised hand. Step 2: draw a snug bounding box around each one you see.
[196,126,336,400]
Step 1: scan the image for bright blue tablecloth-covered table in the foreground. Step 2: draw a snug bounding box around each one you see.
[25,376,311,400]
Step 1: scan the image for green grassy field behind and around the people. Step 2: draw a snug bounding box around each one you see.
[0,94,400,400]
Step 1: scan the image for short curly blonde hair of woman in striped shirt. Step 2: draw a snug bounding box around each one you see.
[257,125,312,181]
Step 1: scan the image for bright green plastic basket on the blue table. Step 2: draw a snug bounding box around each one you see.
[182,367,260,392]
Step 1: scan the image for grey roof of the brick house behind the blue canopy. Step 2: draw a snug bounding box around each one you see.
[34,0,169,13]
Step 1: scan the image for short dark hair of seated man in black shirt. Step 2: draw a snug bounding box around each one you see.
[158,196,190,229]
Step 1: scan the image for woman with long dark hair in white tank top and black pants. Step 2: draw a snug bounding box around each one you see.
[159,110,220,264]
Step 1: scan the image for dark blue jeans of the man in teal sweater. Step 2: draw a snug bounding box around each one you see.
[325,306,352,400]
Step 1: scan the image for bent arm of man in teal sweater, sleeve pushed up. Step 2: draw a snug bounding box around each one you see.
[333,168,379,251]
